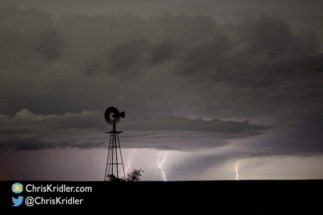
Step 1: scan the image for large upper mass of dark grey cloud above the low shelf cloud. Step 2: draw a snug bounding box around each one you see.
[0,8,322,118]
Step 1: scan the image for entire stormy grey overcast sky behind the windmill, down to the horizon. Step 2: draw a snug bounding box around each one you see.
[0,0,323,180]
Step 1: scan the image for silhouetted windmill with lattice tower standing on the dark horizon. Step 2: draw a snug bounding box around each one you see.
[104,107,125,181]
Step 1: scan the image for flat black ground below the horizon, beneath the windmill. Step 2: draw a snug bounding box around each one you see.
[0,180,323,214]
